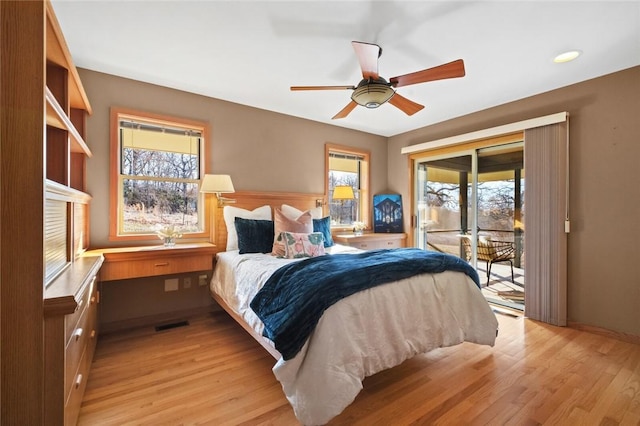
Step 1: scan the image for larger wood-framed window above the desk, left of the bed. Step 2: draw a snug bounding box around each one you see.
[110,111,209,240]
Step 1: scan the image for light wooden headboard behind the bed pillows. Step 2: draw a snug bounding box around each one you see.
[211,191,326,251]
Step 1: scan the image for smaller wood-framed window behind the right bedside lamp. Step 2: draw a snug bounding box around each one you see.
[325,144,371,229]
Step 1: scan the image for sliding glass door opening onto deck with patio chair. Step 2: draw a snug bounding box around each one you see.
[414,143,525,309]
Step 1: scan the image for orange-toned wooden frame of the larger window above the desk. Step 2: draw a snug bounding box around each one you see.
[109,108,212,242]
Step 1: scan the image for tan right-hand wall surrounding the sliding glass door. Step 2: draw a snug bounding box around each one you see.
[388,67,640,336]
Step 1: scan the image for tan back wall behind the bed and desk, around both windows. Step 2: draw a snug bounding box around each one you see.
[79,69,387,325]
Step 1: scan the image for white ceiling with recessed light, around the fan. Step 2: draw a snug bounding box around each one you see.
[52,0,640,136]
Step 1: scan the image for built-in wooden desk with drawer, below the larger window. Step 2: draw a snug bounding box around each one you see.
[85,243,219,281]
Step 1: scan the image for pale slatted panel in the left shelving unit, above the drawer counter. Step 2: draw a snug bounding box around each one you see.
[44,200,69,283]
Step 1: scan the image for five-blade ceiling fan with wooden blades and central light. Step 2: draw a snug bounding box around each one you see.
[291,41,465,120]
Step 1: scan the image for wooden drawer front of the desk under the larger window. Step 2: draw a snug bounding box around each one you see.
[100,254,212,281]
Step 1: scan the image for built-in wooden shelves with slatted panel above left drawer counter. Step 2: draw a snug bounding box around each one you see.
[44,1,92,274]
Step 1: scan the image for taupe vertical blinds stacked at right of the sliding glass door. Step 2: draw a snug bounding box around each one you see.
[524,122,569,326]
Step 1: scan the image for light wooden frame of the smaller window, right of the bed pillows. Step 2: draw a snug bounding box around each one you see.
[324,143,373,232]
